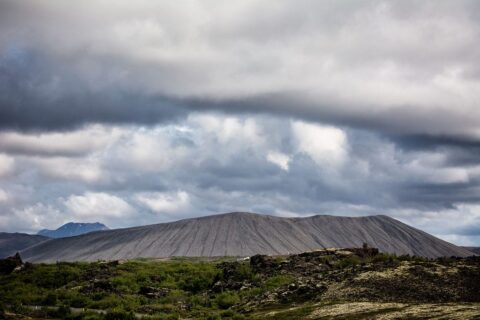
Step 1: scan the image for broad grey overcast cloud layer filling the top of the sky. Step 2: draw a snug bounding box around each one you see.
[0,1,480,139]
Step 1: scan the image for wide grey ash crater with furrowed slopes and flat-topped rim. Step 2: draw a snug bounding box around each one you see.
[22,213,472,262]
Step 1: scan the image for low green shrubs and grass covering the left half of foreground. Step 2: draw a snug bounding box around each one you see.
[0,259,255,319]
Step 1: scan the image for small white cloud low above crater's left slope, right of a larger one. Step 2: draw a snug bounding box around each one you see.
[136,191,190,213]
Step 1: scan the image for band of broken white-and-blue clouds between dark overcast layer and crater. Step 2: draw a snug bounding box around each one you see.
[0,114,480,241]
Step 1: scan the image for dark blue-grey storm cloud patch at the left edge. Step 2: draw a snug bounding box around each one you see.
[0,52,186,130]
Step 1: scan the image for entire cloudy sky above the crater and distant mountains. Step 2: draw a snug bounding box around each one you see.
[0,0,480,245]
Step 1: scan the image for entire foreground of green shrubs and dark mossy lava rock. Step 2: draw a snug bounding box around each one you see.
[0,248,480,320]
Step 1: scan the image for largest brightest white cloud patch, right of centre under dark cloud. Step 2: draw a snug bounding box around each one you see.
[291,121,348,168]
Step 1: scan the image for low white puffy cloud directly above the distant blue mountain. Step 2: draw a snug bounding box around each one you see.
[64,192,134,219]
